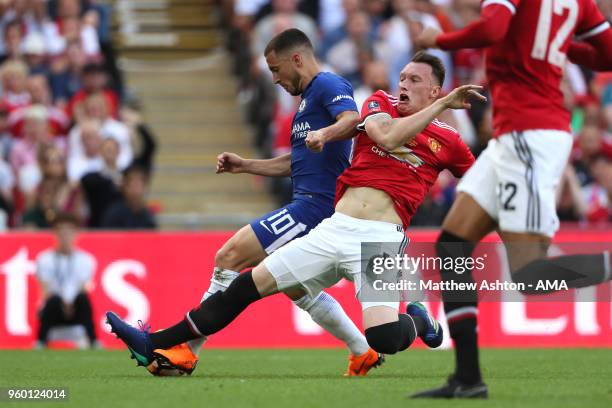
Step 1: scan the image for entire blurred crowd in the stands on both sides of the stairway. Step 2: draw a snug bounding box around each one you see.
[0,0,612,231]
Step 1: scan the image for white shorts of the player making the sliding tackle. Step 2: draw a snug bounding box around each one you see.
[264,213,408,309]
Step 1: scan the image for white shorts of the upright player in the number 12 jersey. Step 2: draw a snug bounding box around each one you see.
[457,130,573,237]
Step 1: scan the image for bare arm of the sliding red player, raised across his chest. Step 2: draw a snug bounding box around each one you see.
[365,85,487,151]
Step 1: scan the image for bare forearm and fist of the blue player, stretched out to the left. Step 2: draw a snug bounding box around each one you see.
[217,152,291,177]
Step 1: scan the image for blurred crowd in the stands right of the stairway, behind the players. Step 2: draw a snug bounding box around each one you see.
[223,0,612,227]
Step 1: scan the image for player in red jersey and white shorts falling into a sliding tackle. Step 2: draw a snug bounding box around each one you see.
[107,53,484,374]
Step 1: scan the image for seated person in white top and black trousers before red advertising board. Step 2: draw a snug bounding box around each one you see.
[36,214,99,348]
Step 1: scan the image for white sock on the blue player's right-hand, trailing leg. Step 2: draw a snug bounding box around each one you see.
[293,292,370,356]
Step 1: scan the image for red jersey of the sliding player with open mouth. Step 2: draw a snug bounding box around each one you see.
[336,91,474,227]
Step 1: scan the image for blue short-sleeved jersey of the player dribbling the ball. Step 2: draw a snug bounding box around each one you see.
[291,72,358,205]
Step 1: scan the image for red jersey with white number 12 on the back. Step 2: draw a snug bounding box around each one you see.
[482,0,609,136]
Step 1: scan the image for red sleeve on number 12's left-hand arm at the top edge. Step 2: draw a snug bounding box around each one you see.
[436,0,518,50]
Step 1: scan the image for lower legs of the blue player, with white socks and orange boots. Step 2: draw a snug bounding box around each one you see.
[149,225,372,376]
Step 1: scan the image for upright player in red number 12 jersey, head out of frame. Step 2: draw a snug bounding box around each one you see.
[414,0,612,398]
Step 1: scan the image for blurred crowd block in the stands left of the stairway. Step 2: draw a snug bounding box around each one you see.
[0,0,155,231]
